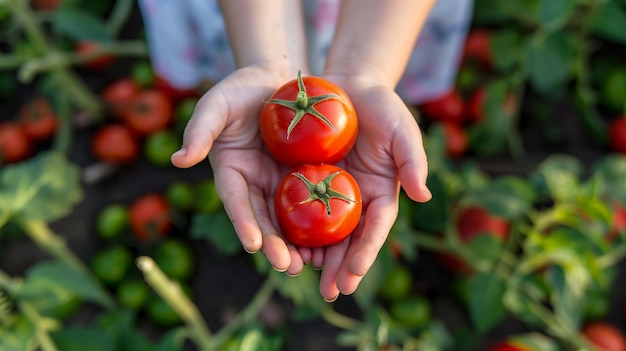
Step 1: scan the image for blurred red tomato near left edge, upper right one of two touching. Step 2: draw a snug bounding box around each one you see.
[19,97,59,141]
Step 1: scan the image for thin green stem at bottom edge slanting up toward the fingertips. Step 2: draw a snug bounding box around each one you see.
[212,276,276,348]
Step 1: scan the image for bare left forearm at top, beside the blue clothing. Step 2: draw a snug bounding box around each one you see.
[219,0,306,75]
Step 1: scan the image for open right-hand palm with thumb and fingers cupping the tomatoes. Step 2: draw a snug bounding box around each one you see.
[298,76,431,301]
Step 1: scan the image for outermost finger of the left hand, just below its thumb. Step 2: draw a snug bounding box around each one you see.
[214,167,263,253]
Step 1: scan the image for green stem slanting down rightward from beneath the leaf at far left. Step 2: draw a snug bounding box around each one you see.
[16,217,115,309]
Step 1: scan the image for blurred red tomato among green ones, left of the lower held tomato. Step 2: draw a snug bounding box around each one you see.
[128,193,172,241]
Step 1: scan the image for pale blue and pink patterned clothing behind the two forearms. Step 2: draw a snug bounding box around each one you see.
[139,0,473,104]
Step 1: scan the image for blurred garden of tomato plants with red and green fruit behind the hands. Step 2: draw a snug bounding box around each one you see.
[0,0,626,351]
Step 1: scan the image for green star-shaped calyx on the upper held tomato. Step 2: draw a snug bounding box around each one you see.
[267,71,345,139]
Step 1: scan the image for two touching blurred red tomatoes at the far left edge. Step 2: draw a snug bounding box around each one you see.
[0,97,59,163]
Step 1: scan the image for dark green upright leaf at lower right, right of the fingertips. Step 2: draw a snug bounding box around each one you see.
[468,273,506,332]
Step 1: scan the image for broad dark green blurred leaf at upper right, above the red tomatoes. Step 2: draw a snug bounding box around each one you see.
[526,31,576,94]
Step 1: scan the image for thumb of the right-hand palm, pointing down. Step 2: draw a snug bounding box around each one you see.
[391,110,432,202]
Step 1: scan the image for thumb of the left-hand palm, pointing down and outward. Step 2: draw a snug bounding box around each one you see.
[171,88,228,168]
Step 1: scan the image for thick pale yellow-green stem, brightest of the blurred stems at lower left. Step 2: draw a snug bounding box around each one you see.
[137,256,212,350]
